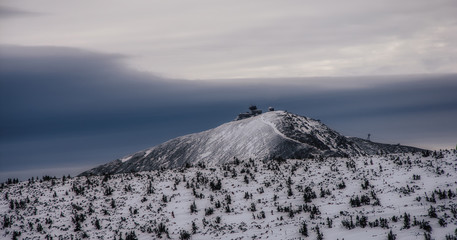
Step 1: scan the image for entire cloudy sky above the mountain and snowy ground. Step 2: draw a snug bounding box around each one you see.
[0,0,457,181]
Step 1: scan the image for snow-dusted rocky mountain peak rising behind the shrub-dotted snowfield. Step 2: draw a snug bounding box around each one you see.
[81,111,423,175]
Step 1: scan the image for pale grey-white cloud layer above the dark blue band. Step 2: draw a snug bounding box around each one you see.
[0,0,457,79]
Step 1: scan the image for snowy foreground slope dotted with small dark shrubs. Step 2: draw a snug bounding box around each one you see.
[0,150,457,240]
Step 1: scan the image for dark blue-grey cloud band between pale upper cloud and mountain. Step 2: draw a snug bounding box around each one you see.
[0,45,457,180]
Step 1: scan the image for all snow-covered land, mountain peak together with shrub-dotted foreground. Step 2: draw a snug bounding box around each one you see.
[0,111,457,240]
